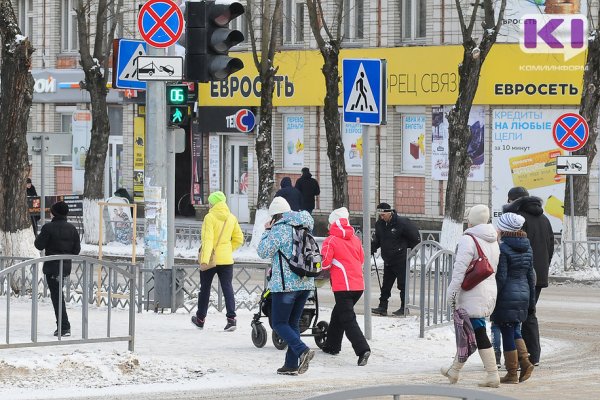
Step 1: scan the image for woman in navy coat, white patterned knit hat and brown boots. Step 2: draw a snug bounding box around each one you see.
[490,213,535,383]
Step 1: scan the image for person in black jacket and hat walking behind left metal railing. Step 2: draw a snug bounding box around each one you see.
[34,201,81,336]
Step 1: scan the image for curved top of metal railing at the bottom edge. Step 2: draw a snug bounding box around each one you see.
[306,385,515,400]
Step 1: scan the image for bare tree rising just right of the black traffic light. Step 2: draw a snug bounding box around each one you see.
[245,0,283,209]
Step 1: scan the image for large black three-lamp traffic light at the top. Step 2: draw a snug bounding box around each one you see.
[185,1,244,82]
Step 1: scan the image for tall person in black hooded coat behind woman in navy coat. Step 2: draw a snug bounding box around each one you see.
[502,186,554,365]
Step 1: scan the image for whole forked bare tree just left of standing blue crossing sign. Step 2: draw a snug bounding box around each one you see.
[306,0,349,208]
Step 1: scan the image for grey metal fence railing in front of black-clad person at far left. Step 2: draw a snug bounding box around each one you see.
[0,255,136,351]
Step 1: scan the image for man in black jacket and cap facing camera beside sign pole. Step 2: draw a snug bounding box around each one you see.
[371,203,421,316]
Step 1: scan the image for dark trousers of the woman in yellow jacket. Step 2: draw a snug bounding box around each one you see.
[196,265,236,321]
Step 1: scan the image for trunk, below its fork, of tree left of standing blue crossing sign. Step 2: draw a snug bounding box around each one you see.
[321,40,349,209]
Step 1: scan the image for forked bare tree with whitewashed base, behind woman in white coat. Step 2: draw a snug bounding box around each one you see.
[440,0,506,249]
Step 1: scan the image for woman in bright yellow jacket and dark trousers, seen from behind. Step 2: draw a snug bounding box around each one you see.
[192,192,244,332]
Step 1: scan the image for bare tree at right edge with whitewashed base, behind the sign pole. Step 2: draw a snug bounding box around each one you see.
[563,7,600,263]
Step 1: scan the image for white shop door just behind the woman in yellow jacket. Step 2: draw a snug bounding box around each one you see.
[226,139,250,222]
